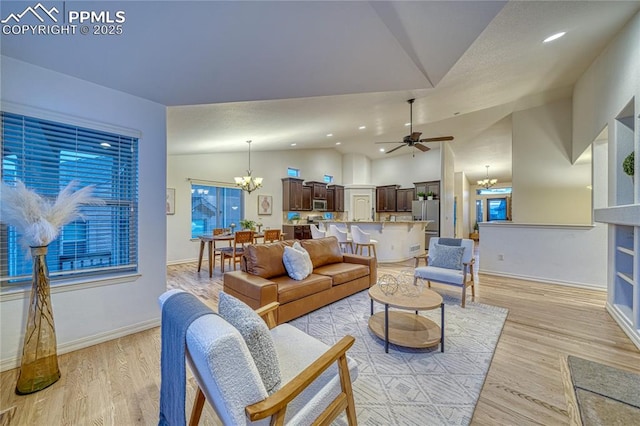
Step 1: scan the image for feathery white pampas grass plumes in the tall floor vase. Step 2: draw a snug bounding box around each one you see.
[0,180,104,249]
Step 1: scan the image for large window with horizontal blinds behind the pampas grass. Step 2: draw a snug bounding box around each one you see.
[0,112,138,285]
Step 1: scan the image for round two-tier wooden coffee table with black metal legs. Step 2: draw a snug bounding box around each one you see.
[369,284,444,353]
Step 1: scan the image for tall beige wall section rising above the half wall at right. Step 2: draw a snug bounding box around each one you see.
[512,99,593,224]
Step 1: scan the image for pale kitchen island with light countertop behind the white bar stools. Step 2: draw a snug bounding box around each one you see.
[321,220,430,263]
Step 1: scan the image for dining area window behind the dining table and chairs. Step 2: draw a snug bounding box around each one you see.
[191,183,244,238]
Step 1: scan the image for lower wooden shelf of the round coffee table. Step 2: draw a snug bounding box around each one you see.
[369,311,444,349]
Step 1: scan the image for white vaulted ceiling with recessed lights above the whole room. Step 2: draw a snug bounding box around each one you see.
[0,0,640,181]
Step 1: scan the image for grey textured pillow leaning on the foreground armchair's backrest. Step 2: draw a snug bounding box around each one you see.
[218,292,282,394]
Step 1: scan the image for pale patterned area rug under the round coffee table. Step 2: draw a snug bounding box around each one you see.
[290,291,508,425]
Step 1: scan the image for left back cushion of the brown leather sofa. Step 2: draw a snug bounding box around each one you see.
[241,241,293,279]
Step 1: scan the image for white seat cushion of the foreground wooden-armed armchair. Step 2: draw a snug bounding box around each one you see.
[271,324,358,426]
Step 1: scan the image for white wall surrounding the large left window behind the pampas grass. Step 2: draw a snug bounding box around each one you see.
[0,57,166,374]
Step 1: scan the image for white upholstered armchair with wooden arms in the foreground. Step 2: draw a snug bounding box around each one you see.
[159,290,358,425]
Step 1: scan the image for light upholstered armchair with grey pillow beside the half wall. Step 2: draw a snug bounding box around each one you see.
[413,238,476,308]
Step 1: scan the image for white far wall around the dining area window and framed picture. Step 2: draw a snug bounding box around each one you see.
[166,149,342,263]
